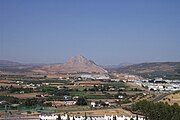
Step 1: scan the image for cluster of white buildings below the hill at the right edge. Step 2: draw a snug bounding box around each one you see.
[135,78,180,91]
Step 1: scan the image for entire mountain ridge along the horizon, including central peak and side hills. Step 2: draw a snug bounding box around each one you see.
[0,58,180,76]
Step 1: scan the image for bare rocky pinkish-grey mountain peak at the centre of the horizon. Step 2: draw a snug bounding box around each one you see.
[36,55,107,73]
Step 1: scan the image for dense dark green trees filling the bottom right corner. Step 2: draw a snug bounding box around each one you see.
[132,100,180,120]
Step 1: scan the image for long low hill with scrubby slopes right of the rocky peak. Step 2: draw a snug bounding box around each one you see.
[114,62,180,79]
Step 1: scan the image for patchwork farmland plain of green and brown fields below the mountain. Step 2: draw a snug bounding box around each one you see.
[0,76,151,116]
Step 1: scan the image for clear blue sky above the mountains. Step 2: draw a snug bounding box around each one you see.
[0,0,180,65]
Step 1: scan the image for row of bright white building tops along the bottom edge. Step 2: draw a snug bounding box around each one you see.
[39,114,145,120]
